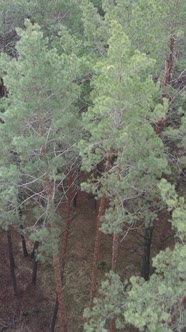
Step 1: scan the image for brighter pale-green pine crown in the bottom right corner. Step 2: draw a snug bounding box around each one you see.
[124,235,186,332]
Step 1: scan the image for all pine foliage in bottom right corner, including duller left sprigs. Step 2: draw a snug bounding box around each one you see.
[85,196,186,332]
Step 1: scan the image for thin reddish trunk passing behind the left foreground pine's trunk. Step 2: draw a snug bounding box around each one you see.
[51,171,74,332]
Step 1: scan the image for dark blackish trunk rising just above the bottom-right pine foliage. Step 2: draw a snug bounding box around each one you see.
[141,226,153,281]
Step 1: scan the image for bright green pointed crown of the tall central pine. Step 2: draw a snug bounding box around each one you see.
[79,21,168,233]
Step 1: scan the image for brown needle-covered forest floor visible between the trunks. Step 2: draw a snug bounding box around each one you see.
[0,192,174,332]
